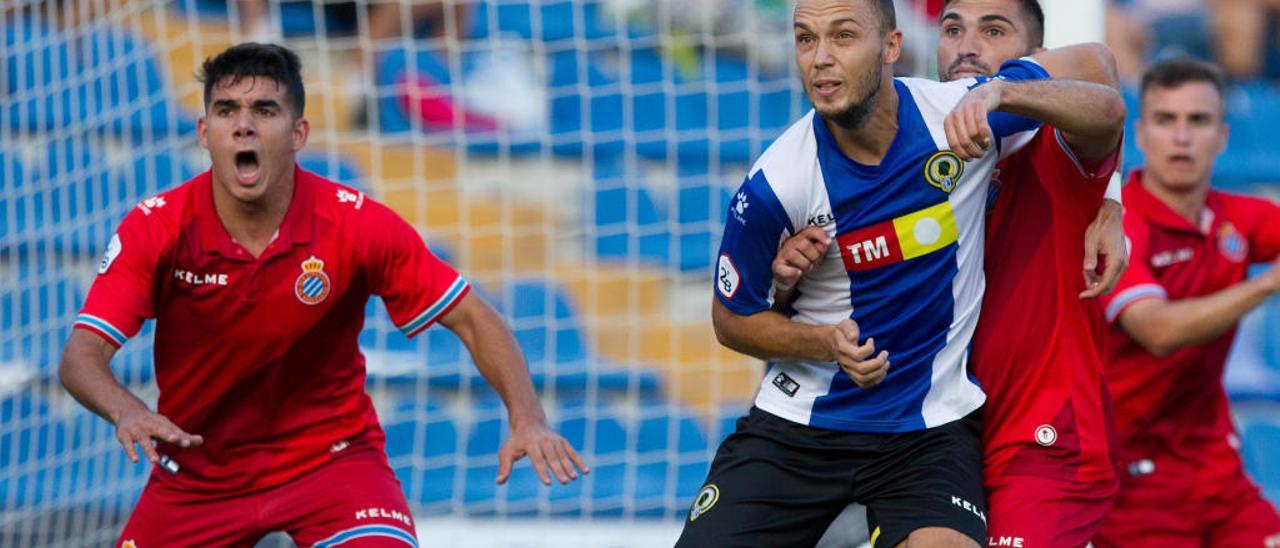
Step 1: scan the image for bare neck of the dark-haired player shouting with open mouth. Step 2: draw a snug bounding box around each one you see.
[214,169,296,259]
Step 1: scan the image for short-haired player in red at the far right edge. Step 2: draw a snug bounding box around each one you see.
[1094,59,1280,548]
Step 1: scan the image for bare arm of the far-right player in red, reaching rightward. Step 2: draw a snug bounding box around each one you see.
[1119,257,1280,357]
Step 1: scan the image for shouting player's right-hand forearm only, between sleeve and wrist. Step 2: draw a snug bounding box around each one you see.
[445,294,547,429]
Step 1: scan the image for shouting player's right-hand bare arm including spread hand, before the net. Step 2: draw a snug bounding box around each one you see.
[440,293,590,485]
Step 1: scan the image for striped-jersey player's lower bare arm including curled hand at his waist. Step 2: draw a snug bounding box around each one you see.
[712,298,890,388]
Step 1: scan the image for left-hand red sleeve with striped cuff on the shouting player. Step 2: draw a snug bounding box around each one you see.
[74,207,166,348]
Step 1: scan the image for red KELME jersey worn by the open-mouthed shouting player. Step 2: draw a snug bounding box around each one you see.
[76,168,468,496]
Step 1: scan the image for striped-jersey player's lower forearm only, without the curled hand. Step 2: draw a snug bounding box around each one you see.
[712,300,835,361]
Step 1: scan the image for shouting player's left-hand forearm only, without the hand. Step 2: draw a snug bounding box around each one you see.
[58,329,147,424]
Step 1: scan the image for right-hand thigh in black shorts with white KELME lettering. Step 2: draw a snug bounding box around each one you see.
[855,415,987,545]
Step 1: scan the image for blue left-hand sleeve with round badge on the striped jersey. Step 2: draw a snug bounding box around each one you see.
[714,170,795,316]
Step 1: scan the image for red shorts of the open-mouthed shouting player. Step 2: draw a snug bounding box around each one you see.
[115,447,417,548]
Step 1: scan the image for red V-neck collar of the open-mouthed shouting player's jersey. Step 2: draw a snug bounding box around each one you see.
[195,164,316,260]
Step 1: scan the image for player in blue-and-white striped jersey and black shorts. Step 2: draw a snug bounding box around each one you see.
[678,0,1126,547]
